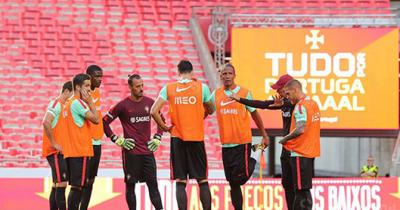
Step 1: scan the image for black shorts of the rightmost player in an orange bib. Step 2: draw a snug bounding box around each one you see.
[290,157,314,190]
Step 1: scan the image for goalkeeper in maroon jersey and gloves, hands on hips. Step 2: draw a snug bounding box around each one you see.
[103,74,163,210]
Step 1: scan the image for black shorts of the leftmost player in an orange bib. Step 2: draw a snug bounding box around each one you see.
[46,153,68,183]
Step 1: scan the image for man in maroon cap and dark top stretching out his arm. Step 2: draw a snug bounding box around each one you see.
[231,74,294,210]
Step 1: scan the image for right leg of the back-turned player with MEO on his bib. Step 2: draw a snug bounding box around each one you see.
[186,142,211,210]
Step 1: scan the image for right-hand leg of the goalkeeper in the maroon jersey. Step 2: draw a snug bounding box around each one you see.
[142,154,163,210]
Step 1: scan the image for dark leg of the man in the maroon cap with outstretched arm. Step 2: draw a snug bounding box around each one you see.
[280,147,294,210]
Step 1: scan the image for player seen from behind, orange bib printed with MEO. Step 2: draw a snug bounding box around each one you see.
[151,60,214,210]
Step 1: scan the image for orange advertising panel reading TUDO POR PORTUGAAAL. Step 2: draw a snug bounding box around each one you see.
[232,28,399,129]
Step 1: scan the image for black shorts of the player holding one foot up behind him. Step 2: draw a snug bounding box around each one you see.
[222,143,257,185]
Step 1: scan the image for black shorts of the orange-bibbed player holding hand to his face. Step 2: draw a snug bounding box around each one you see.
[66,157,90,187]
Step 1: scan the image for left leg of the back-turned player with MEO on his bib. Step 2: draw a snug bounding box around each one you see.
[170,137,188,210]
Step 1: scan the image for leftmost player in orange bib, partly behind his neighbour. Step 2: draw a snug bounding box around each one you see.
[42,81,73,210]
